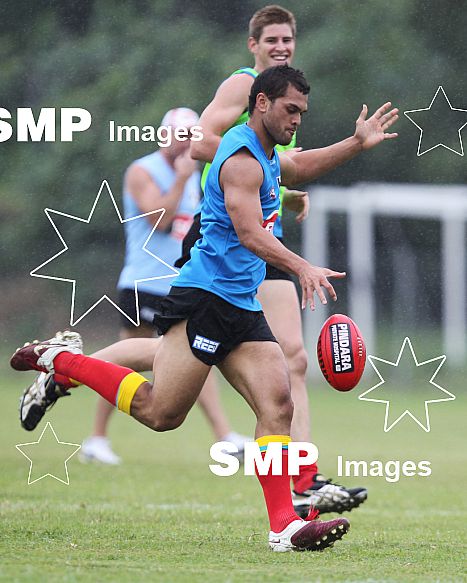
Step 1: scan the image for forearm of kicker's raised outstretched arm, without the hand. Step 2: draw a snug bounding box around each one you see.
[286,136,362,186]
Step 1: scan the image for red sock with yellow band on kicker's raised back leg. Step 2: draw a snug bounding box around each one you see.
[54,352,148,415]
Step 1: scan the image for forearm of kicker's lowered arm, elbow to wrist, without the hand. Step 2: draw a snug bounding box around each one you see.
[237,227,307,276]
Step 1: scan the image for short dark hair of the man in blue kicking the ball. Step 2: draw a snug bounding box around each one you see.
[248,65,310,115]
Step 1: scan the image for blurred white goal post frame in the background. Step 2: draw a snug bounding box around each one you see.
[302,183,467,366]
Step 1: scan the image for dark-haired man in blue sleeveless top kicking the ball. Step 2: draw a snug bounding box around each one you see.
[11,66,396,551]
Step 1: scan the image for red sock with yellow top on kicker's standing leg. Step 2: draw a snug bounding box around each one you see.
[256,435,299,532]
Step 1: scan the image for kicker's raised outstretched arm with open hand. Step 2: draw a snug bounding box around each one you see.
[280,102,399,186]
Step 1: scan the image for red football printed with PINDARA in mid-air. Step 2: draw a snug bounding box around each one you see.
[317,314,366,391]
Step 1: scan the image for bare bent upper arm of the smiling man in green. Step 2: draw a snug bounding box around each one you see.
[190,74,254,162]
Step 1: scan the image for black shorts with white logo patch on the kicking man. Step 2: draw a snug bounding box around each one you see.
[154,286,277,366]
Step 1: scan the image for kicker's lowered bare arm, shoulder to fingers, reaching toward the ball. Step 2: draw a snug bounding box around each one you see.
[219,150,345,309]
